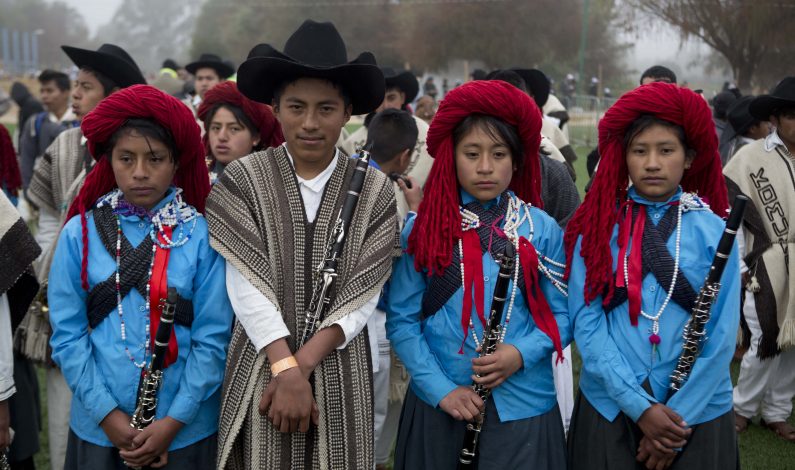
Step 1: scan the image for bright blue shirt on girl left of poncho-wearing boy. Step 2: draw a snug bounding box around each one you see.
[48,190,233,450]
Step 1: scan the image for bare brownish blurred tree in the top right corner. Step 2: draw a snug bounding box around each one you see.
[626,0,795,92]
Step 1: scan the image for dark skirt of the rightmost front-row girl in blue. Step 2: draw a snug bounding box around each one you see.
[568,393,740,470]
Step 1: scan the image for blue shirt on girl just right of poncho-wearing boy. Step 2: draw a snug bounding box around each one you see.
[386,193,571,422]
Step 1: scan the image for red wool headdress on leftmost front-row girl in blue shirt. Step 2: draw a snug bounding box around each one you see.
[66,85,210,220]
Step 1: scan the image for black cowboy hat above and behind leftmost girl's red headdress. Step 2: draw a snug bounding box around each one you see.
[61,44,146,88]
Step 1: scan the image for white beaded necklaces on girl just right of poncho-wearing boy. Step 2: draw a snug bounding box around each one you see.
[458,195,568,347]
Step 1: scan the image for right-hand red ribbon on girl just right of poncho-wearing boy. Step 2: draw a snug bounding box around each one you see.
[519,237,563,362]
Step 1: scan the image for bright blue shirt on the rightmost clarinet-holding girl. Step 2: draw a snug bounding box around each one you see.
[569,188,740,425]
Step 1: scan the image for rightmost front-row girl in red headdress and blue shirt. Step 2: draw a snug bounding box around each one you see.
[565,83,740,470]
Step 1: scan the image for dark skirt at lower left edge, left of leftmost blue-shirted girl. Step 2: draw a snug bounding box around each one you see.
[8,352,41,462]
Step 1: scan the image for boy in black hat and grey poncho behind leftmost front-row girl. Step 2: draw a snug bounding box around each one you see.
[20,44,146,465]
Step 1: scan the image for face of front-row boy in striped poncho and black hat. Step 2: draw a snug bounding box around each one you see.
[273,78,352,169]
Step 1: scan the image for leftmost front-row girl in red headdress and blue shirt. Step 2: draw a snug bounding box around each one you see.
[48,85,232,469]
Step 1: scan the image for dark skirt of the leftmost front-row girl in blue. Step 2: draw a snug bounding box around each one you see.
[64,429,218,470]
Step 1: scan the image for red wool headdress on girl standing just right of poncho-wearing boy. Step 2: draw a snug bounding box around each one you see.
[408,80,543,274]
